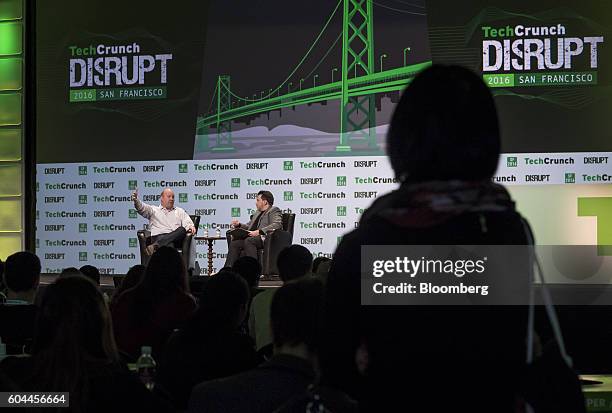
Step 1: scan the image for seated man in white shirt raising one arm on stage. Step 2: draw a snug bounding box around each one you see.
[132,188,196,255]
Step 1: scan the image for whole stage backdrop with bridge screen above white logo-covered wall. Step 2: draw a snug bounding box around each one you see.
[36,0,612,282]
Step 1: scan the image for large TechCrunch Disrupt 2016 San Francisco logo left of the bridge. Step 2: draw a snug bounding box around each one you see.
[68,43,172,102]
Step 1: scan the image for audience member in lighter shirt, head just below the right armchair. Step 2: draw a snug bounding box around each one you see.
[249,245,312,356]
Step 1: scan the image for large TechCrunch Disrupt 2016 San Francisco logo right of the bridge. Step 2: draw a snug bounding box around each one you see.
[481,24,604,87]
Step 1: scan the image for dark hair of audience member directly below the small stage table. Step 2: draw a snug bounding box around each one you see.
[185,269,250,334]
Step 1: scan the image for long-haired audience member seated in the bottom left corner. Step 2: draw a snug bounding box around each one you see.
[0,275,170,412]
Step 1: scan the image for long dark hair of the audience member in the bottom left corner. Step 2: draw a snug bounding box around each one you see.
[28,275,119,411]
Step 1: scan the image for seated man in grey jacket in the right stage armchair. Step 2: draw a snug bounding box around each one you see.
[225,191,283,267]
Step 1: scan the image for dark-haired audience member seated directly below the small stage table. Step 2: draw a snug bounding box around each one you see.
[158,271,259,409]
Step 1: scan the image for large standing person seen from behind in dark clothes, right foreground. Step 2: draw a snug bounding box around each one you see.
[321,66,581,412]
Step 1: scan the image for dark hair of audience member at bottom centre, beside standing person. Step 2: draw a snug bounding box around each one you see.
[270,278,323,351]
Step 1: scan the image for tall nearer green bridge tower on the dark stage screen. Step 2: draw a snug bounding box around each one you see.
[336,0,378,152]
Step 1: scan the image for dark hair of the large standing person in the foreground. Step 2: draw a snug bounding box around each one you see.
[387,65,501,182]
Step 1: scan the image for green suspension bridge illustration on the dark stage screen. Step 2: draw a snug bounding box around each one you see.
[197,0,431,154]
